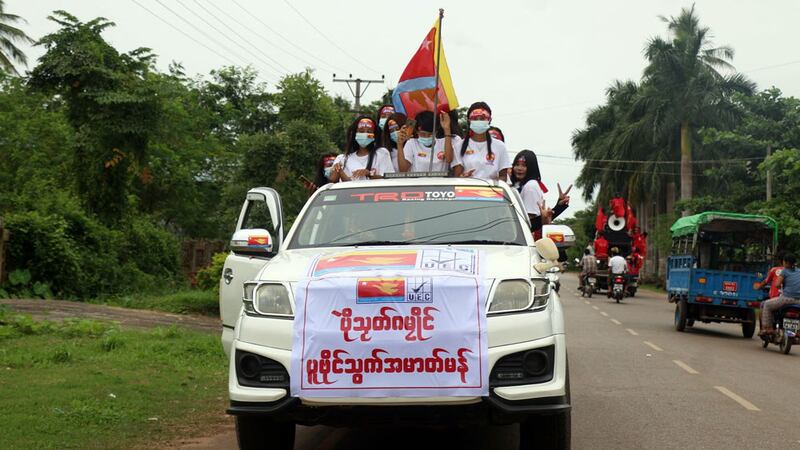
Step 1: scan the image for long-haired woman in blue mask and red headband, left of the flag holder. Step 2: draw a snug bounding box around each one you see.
[330,116,394,183]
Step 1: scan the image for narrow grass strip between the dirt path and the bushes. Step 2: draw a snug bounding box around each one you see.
[89,289,219,317]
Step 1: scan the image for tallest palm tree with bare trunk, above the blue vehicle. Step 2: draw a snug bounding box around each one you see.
[641,6,755,214]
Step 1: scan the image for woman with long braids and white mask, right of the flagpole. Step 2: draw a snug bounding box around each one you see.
[453,102,511,181]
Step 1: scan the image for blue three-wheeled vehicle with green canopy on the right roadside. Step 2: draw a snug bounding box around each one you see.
[667,211,778,338]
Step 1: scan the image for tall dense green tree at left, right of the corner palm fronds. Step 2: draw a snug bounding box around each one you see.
[30,11,161,223]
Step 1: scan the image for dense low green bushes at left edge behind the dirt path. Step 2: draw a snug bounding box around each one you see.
[6,205,179,298]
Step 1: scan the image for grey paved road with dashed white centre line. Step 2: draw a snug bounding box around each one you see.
[177,275,800,450]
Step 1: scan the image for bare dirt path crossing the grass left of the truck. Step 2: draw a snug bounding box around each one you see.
[0,299,222,333]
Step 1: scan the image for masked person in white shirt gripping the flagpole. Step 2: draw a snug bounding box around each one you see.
[397,111,461,172]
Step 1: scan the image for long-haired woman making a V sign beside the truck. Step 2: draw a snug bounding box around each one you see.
[509,150,572,239]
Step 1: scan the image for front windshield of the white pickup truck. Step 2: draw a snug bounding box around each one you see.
[289,186,527,248]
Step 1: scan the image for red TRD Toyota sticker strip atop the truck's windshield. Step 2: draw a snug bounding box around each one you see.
[338,186,505,203]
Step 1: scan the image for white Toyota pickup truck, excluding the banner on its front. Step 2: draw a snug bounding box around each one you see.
[220,178,571,449]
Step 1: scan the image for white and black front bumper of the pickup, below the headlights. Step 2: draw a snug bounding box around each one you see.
[228,334,571,425]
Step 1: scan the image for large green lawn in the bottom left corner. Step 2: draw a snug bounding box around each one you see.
[0,309,227,449]
